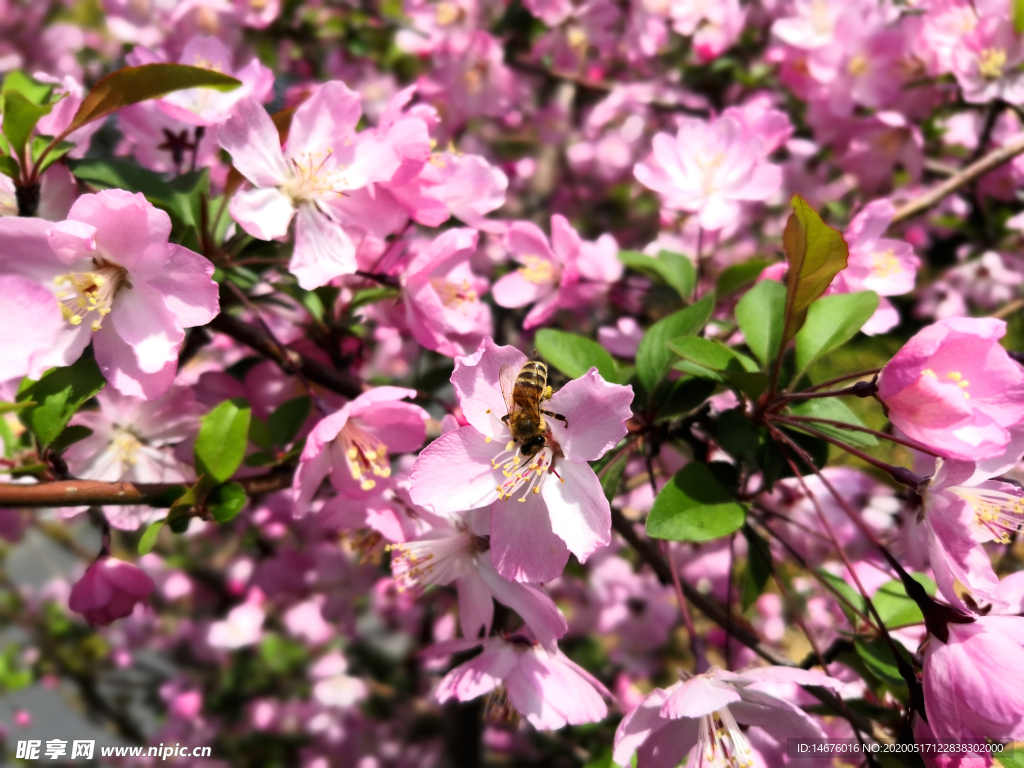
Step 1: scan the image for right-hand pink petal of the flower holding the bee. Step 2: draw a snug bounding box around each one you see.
[548,368,633,462]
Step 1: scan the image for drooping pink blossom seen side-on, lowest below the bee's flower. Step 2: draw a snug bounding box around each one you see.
[432,635,611,730]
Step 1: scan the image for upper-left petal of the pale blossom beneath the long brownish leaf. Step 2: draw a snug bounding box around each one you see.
[217,98,290,186]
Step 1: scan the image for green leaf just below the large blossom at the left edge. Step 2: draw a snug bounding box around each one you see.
[17,357,106,446]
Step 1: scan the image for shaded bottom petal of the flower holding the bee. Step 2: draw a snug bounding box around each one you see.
[490,494,569,584]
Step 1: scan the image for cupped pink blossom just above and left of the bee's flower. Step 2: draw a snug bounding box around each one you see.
[403,229,494,357]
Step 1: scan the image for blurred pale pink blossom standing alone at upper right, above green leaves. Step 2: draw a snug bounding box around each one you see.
[634,116,782,229]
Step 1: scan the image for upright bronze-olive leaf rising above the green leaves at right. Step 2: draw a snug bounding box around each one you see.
[781,195,850,347]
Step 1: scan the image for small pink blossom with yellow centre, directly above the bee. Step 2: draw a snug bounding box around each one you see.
[492,213,580,330]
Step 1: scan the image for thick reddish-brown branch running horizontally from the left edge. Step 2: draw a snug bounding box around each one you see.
[0,470,292,509]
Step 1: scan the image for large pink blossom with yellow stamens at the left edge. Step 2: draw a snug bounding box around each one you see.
[0,189,219,399]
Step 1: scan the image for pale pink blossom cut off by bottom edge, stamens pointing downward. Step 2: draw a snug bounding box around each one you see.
[612,667,839,768]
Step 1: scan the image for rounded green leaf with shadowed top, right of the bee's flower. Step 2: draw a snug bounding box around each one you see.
[647,462,746,542]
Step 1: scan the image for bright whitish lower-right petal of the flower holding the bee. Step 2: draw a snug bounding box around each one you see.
[541,461,611,562]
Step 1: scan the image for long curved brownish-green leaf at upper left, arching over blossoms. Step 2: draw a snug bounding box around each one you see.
[60,63,242,138]
